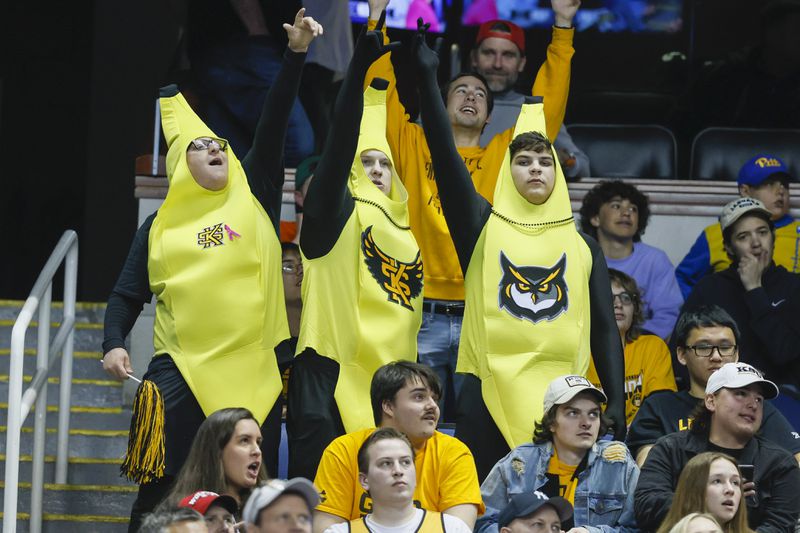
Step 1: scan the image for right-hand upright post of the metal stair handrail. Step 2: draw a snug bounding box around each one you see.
[56,239,78,485]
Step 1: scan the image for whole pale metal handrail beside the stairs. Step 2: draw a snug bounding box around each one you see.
[3,230,78,533]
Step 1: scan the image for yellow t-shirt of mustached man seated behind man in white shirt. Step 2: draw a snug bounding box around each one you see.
[314,428,486,520]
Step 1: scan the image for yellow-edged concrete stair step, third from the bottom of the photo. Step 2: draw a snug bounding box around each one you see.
[0,455,137,487]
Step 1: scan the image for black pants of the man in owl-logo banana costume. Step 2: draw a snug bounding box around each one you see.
[455,374,511,483]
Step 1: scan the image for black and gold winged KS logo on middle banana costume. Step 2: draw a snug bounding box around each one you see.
[361,226,422,311]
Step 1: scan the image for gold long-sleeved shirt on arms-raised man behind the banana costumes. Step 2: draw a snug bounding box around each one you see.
[365,21,575,300]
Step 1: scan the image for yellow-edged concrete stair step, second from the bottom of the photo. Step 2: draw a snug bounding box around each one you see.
[0,482,138,521]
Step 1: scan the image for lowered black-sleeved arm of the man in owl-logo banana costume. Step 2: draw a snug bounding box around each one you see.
[581,234,627,441]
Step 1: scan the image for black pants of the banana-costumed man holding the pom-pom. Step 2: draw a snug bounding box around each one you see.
[128,355,282,533]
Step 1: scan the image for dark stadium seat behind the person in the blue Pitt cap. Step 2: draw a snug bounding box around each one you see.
[690,128,800,181]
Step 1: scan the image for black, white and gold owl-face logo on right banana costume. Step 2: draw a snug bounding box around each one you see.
[498,251,569,324]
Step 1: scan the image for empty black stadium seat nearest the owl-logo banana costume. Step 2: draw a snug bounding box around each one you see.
[567,124,678,179]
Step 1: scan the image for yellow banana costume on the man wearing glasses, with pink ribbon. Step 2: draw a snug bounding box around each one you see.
[147,94,289,423]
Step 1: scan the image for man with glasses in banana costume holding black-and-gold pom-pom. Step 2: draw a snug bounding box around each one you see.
[103,10,322,531]
